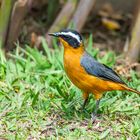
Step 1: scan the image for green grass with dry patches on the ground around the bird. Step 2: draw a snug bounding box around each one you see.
[0,37,140,140]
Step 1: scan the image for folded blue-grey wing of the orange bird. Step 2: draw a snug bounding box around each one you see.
[81,52,125,84]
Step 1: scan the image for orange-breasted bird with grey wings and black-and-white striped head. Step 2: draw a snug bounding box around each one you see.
[49,29,140,123]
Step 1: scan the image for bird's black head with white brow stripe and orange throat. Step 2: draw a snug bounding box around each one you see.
[49,29,83,49]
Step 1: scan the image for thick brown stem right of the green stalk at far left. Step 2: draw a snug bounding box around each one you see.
[6,0,33,50]
